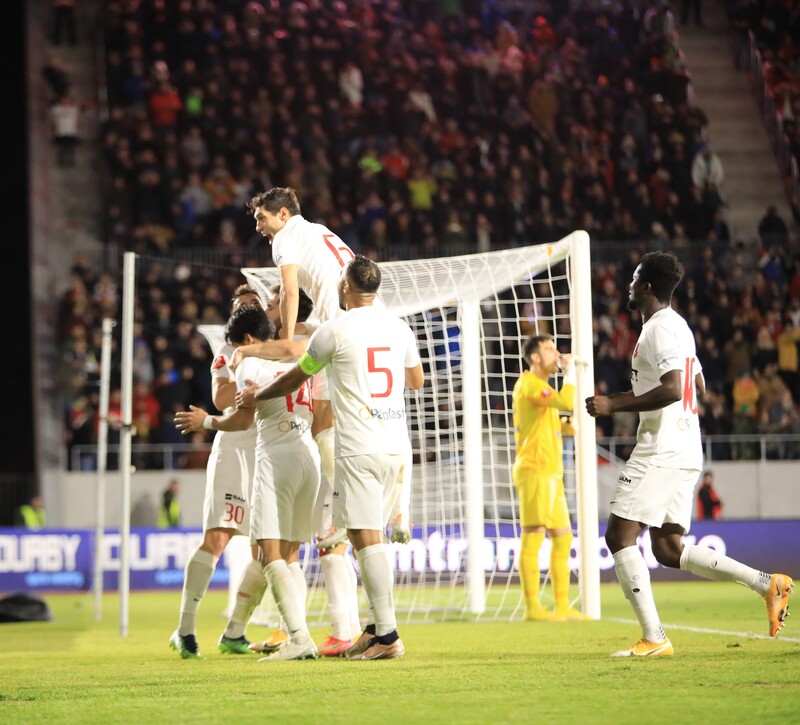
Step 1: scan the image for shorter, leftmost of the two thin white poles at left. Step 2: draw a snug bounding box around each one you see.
[93,317,116,622]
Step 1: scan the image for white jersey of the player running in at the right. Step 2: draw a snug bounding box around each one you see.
[631,307,703,471]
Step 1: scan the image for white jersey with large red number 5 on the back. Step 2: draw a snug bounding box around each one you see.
[306,306,420,457]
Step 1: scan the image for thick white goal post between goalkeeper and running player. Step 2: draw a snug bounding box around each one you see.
[570,231,600,619]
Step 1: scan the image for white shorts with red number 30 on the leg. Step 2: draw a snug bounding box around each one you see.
[203,426,256,536]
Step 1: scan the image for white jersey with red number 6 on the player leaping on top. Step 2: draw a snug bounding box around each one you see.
[272,214,355,322]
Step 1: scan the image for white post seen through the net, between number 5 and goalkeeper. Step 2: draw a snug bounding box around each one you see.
[461,300,486,614]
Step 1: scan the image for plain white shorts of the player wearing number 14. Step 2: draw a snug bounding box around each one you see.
[251,444,319,541]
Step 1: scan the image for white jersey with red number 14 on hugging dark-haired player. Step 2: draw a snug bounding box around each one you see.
[236,357,314,455]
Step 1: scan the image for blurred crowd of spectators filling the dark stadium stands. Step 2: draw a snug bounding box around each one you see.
[51,0,800,465]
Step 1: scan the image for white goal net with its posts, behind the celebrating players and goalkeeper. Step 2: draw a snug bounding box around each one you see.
[234,232,600,626]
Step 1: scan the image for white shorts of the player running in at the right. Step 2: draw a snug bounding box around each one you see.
[609,458,700,531]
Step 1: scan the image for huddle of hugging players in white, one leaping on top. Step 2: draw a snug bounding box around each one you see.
[170,188,423,662]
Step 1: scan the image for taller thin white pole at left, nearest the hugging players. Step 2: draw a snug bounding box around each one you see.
[119,252,136,637]
